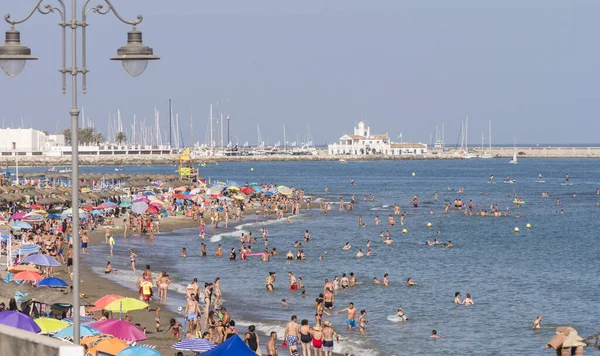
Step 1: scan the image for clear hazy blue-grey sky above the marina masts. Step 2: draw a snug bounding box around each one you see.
[0,0,600,145]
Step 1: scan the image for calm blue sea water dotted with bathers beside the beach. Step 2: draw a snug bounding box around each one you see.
[50,159,600,355]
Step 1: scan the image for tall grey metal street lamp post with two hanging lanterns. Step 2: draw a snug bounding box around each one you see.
[0,0,159,345]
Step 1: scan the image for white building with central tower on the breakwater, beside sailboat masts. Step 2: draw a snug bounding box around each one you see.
[328,121,427,156]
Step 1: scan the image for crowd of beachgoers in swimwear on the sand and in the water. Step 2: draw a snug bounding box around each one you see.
[0,174,600,356]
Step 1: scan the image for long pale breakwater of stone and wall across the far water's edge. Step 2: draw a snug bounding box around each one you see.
[0,147,600,167]
